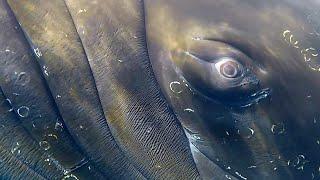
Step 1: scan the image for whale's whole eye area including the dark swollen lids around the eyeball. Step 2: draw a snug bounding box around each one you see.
[172,40,265,104]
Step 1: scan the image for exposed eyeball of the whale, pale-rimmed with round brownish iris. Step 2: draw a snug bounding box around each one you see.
[215,58,243,78]
